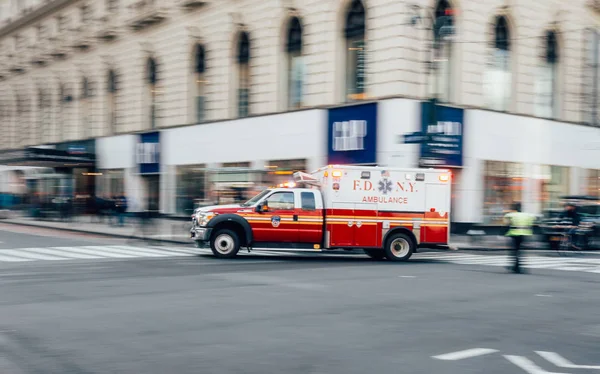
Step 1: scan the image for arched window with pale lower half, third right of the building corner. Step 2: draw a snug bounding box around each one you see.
[536,30,560,118]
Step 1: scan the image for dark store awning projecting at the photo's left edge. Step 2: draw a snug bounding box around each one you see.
[0,147,96,168]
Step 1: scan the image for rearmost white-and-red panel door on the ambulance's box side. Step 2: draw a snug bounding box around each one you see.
[421,183,450,244]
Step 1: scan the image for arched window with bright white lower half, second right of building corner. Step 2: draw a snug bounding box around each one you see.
[485,16,512,111]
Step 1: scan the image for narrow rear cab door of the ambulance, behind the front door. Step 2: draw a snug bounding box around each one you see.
[294,190,323,245]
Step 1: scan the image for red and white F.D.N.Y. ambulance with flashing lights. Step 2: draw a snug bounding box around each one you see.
[191,165,451,261]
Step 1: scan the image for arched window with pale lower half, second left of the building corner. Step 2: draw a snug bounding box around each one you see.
[285,17,304,109]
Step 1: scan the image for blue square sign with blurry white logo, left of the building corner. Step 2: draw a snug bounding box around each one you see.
[327,103,377,165]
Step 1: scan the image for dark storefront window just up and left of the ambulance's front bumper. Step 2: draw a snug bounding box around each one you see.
[176,165,210,215]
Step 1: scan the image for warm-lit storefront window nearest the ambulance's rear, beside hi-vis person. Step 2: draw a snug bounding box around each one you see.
[483,161,525,225]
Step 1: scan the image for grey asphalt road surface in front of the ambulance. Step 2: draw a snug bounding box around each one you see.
[0,225,600,374]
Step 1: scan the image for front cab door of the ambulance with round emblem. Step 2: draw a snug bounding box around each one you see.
[252,191,298,243]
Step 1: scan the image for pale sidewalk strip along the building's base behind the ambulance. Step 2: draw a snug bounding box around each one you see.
[0,213,546,251]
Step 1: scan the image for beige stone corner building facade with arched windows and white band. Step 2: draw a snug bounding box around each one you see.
[0,0,600,228]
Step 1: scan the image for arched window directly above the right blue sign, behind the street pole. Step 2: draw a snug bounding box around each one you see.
[433,0,455,102]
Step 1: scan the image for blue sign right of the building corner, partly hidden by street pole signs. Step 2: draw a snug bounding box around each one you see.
[419,102,464,168]
